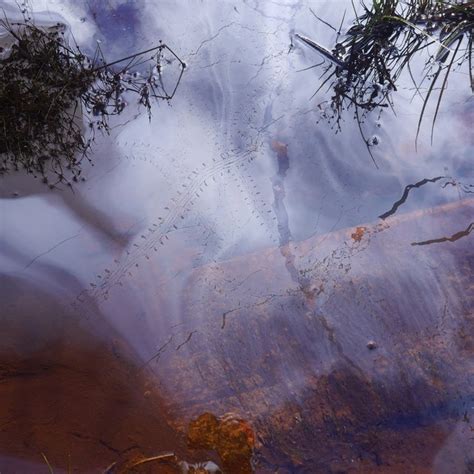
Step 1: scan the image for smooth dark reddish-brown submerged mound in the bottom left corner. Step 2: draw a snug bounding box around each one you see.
[0,276,184,474]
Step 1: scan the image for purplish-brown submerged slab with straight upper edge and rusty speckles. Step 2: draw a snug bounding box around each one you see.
[149,195,474,473]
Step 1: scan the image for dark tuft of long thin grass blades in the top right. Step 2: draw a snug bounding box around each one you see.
[300,0,474,162]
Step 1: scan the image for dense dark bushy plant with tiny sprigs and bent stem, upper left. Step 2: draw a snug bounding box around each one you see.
[0,12,184,186]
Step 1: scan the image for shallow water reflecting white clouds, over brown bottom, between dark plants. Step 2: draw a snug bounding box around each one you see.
[0,0,474,473]
